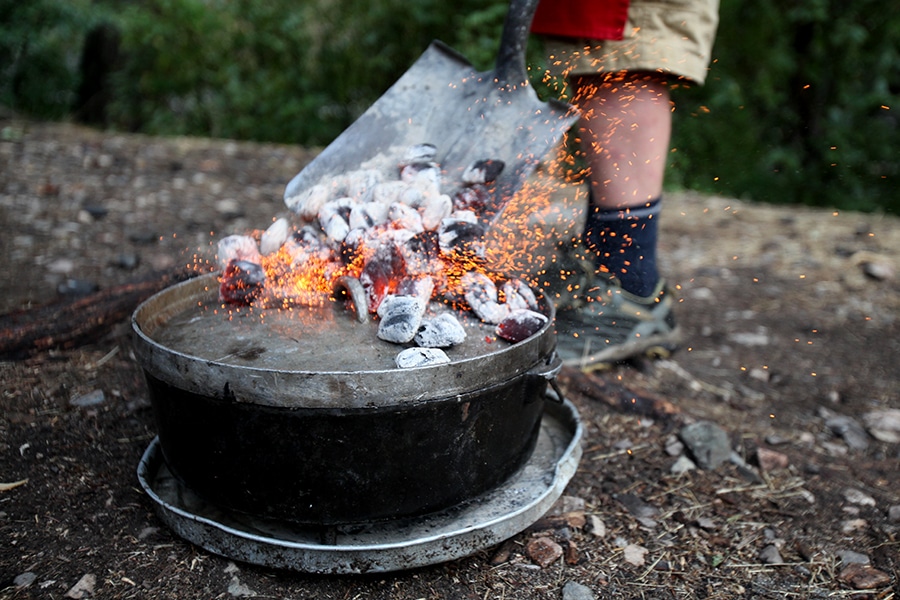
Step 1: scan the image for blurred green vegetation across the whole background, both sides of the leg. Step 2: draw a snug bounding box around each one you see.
[0,0,900,213]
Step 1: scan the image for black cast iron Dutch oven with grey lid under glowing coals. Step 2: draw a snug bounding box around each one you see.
[132,274,559,525]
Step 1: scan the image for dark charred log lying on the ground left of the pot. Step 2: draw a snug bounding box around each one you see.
[0,271,193,360]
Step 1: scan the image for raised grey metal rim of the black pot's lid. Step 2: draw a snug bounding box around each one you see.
[131,273,556,408]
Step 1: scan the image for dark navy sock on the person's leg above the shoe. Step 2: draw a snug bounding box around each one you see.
[584,198,660,297]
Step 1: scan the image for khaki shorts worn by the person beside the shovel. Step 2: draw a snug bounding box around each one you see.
[546,0,719,84]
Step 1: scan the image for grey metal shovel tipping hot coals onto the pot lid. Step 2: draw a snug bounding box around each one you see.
[285,0,578,227]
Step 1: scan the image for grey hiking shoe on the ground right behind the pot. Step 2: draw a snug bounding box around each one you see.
[556,279,681,371]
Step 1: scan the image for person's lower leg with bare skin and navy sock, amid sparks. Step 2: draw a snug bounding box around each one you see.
[573,72,672,297]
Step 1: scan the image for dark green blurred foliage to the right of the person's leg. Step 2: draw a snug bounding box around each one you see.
[670,0,900,212]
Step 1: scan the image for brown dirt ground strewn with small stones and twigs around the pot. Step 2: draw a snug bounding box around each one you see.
[0,120,900,600]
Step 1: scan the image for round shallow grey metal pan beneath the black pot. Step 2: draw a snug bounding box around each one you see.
[137,401,582,573]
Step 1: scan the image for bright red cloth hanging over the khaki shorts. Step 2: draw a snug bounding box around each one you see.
[531,0,629,40]
